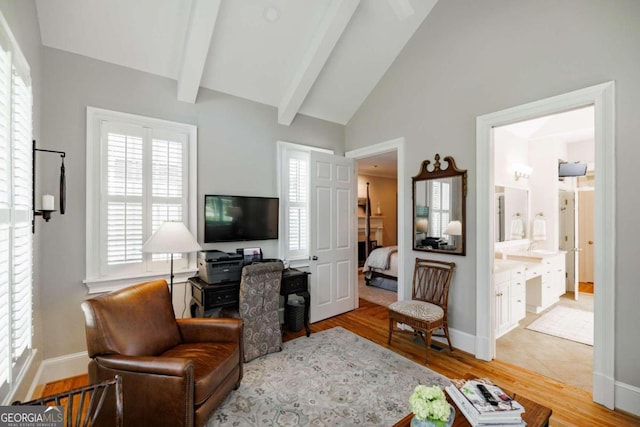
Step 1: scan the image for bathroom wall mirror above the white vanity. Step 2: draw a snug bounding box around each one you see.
[494,185,530,242]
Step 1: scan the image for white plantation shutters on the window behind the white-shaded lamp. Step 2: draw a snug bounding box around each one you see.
[88,110,195,279]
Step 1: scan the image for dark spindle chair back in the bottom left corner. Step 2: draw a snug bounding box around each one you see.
[13,375,124,427]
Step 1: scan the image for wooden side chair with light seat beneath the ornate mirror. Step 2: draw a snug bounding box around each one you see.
[387,258,456,363]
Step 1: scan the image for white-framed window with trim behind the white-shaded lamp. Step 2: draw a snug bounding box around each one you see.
[87,107,196,292]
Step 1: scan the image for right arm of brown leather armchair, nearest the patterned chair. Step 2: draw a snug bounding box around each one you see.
[177,317,242,343]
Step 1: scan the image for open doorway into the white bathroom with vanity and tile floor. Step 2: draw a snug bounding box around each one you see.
[493,106,597,391]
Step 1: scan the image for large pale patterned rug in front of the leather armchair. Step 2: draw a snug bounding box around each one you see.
[207,327,450,427]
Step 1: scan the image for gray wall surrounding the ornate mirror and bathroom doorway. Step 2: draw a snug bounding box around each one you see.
[346,0,640,387]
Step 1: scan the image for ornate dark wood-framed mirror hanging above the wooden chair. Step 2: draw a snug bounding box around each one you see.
[412,154,467,255]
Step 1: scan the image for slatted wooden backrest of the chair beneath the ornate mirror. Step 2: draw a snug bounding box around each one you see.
[412,258,456,313]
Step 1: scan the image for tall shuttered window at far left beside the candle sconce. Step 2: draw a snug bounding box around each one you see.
[0,13,33,404]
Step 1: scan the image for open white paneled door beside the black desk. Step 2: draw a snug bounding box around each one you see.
[309,151,358,322]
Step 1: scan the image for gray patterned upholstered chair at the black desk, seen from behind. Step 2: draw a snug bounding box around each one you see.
[238,261,283,362]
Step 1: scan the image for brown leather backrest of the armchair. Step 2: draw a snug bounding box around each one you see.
[81,280,182,358]
